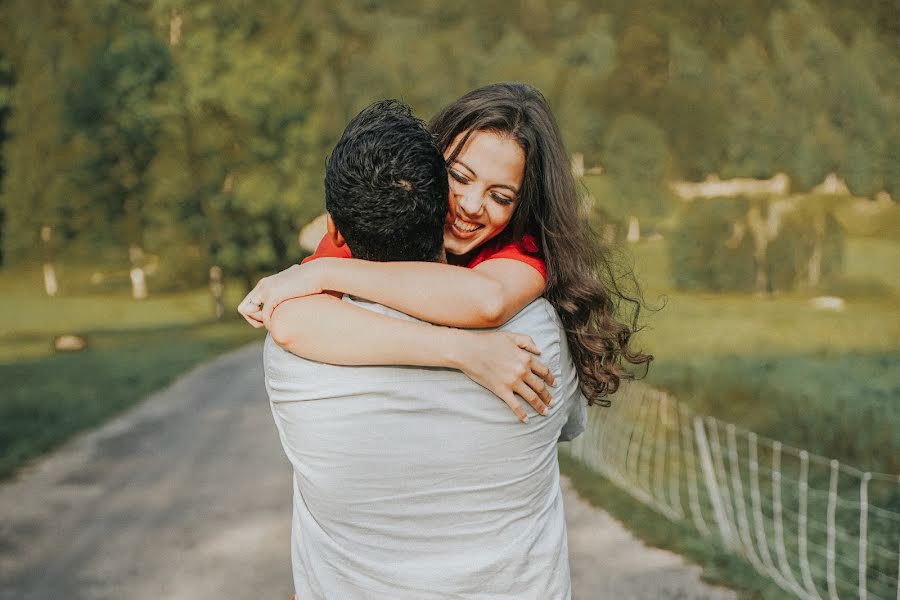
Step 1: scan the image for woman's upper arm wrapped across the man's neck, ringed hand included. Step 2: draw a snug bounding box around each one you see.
[248,258,544,328]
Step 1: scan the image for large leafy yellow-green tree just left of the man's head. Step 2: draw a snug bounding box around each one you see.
[152,0,330,286]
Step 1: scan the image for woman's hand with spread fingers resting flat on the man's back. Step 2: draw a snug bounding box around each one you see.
[457,331,556,423]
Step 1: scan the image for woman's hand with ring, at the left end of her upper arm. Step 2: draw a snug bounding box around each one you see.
[238,258,329,329]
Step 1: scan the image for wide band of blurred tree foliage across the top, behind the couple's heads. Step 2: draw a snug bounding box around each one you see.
[0,0,900,280]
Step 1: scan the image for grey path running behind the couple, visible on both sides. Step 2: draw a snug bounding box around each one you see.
[0,345,732,600]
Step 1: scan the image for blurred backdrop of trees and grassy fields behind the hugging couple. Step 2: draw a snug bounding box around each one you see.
[0,0,900,596]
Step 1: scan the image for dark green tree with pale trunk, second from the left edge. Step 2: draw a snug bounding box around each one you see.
[64,7,172,298]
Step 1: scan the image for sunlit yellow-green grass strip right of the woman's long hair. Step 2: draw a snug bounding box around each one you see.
[630,239,900,363]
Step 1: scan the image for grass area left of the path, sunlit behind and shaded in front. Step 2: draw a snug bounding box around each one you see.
[0,264,261,479]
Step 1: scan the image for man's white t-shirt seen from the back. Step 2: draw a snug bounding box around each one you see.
[264,298,586,600]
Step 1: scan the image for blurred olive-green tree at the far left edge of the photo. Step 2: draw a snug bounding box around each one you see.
[0,0,98,264]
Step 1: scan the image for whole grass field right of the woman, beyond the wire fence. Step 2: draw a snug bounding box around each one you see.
[634,239,900,472]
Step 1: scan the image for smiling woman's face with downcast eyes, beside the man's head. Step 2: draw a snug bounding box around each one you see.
[444,131,525,255]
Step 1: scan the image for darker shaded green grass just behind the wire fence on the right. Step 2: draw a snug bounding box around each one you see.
[648,351,900,474]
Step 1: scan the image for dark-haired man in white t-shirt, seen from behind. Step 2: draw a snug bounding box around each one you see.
[265,101,585,600]
